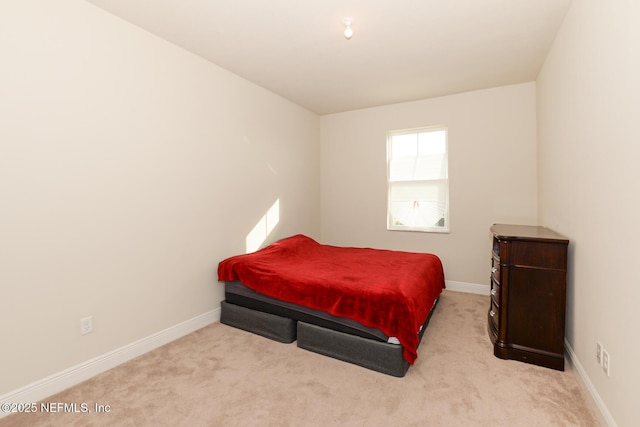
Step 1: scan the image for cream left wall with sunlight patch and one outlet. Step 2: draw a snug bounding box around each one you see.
[0,0,320,395]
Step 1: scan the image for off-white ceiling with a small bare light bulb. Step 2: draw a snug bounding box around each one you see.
[86,0,571,115]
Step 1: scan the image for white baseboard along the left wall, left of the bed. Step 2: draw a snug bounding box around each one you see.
[0,308,220,418]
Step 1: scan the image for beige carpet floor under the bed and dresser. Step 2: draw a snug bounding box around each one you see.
[0,291,598,427]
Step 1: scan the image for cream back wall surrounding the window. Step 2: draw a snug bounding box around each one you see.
[320,83,537,285]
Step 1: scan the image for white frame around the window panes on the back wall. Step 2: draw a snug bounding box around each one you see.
[387,126,451,233]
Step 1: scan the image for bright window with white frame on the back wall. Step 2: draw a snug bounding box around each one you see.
[387,127,449,233]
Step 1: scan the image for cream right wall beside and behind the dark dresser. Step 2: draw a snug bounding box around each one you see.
[537,0,640,426]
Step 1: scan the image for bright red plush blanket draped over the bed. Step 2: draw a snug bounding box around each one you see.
[218,235,444,364]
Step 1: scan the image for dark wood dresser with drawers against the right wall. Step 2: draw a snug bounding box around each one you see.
[488,224,569,371]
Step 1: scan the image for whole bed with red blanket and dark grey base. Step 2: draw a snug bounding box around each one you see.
[218,234,445,377]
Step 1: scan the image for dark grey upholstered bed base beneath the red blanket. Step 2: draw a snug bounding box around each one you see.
[220,300,438,377]
